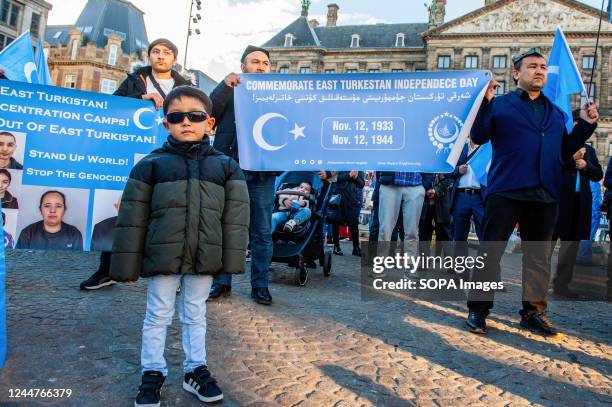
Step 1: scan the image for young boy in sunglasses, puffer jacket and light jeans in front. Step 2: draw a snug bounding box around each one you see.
[110,86,249,406]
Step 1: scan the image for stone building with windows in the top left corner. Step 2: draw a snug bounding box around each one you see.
[0,0,52,50]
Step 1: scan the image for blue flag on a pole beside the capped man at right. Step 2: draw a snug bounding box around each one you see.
[542,27,586,132]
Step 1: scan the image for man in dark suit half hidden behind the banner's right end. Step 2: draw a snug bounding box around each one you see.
[449,139,484,262]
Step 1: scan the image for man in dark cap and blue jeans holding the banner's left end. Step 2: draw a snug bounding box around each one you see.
[210,45,276,305]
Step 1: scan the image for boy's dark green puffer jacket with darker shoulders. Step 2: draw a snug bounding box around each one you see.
[110,137,249,281]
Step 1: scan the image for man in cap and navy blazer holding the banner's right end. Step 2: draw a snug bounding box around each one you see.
[466,48,599,335]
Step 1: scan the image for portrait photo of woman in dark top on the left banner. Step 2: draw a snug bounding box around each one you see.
[15,185,90,250]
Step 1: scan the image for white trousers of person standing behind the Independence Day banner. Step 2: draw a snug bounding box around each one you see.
[378,185,425,242]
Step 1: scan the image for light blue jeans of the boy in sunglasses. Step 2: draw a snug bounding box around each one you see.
[140,275,212,376]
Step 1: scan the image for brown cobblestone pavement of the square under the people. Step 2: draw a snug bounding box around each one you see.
[0,246,612,407]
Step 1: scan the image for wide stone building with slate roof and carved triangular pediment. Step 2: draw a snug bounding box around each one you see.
[264,0,612,164]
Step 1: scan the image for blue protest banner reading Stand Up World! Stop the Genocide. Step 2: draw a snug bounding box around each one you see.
[0,81,166,250]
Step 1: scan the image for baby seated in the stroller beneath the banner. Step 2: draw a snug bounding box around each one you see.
[272,182,314,232]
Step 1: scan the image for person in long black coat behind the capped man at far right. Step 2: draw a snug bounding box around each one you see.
[552,144,603,298]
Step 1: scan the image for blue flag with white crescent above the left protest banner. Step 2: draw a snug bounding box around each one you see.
[0,31,38,83]
